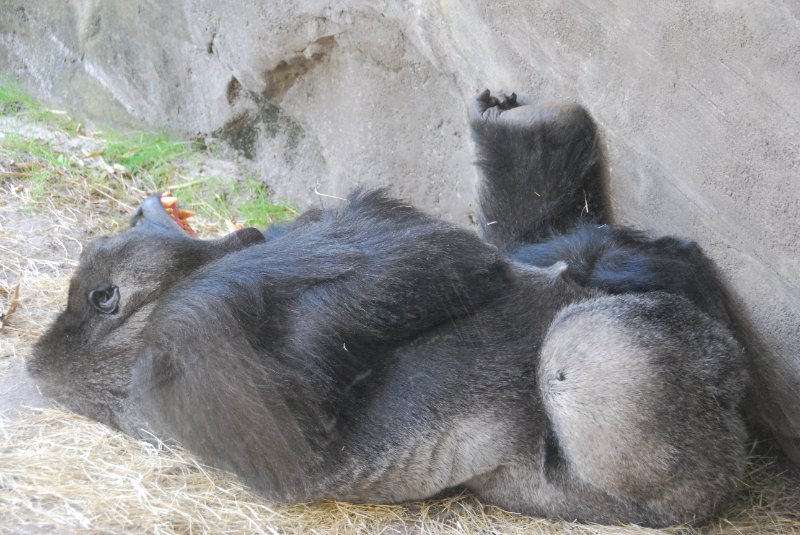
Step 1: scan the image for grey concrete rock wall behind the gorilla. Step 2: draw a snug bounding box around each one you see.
[0,0,800,462]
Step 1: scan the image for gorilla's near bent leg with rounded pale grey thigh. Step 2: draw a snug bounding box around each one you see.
[468,292,747,526]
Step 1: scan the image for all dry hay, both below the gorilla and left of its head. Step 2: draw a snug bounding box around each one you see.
[0,122,800,534]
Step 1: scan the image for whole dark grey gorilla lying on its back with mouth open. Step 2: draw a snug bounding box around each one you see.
[29,91,747,526]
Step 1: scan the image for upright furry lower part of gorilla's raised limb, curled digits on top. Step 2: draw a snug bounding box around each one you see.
[470,90,608,250]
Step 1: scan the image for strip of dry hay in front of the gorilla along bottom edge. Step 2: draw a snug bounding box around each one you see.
[0,409,800,534]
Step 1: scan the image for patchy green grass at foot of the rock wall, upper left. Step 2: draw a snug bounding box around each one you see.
[0,81,297,227]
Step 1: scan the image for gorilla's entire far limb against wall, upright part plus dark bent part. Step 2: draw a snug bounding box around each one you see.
[470,90,736,327]
